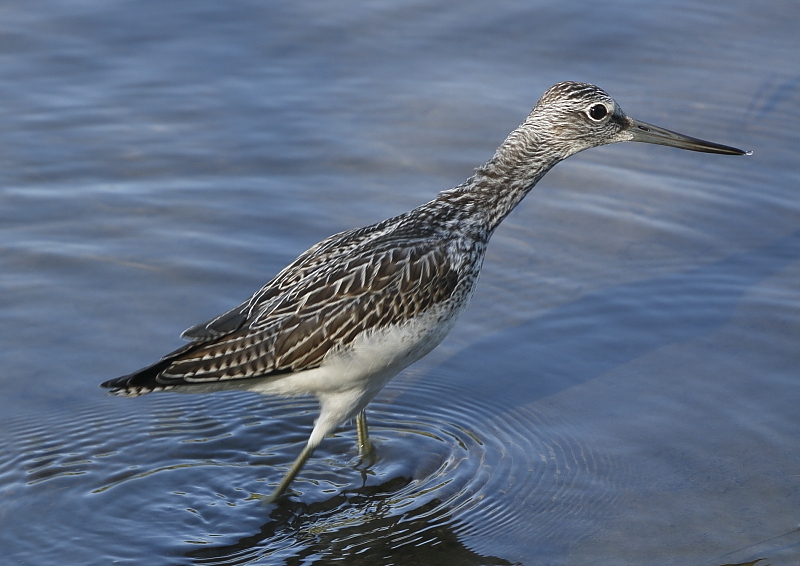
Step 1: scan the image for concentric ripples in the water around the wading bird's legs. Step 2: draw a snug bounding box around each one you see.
[0,372,619,564]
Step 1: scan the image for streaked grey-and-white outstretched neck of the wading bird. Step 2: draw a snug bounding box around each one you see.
[436,124,563,234]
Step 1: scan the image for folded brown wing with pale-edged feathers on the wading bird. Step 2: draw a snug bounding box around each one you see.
[104,222,458,391]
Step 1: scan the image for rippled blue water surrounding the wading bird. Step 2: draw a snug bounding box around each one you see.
[0,1,800,566]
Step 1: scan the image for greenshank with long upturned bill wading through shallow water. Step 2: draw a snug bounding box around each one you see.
[102,82,747,501]
